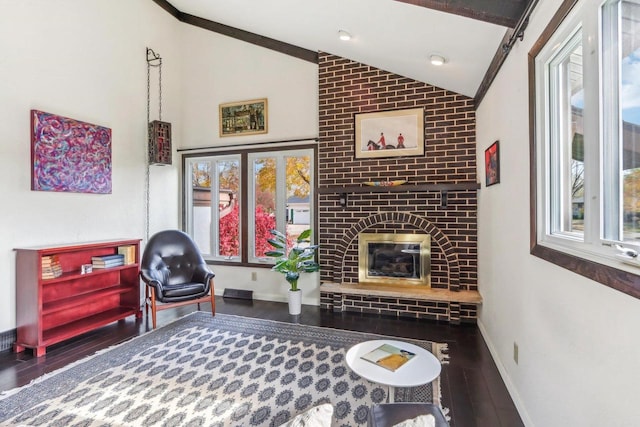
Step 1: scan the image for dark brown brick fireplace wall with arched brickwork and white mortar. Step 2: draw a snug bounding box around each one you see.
[318,53,481,323]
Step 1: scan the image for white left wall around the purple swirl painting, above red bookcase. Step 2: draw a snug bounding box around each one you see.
[0,0,181,331]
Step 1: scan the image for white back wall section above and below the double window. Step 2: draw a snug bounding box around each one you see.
[180,25,320,305]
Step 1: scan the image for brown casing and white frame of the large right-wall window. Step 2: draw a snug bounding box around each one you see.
[528,0,640,298]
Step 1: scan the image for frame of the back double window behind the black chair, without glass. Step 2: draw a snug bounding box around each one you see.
[179,143,318,268]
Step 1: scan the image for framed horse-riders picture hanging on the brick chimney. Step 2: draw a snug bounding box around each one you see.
[355,108,424,159]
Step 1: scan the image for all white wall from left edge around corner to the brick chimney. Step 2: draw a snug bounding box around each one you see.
[0,0,319,338]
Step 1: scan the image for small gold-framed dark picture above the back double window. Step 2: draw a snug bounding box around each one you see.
[219,98,268,137]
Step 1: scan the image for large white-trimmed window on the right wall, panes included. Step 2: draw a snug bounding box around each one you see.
[530,0,640,289]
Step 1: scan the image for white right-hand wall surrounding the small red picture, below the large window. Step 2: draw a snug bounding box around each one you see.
[477,0,640,427]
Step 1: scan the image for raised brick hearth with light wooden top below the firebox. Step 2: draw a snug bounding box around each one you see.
[320,283,482,324]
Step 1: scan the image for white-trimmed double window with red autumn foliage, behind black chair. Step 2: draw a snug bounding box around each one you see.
[183,148,315,264]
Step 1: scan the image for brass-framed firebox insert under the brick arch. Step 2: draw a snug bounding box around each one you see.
[358,233,431,287]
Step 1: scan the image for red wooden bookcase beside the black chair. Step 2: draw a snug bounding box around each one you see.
[13,239,142,357]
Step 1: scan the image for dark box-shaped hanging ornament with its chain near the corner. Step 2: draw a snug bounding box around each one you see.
[147,48,171,165]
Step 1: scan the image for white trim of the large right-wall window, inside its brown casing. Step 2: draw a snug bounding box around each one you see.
[532,0,640,274]
